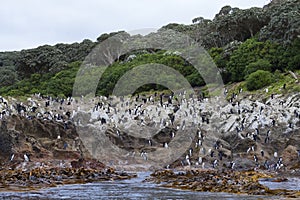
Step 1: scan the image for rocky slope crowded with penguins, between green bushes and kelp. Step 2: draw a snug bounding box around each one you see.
[0,92,300,173]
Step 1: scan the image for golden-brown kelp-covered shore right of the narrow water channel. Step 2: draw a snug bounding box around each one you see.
[145,169,300,198]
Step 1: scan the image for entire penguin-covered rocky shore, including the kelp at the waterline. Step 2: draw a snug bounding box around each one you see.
[0,89,300,197]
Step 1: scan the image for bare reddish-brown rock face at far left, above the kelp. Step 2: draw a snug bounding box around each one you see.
[0,115,90,167]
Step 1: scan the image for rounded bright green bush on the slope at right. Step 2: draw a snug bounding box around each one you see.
[246,70,274,91]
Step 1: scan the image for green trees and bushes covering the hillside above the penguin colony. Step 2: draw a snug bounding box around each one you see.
[0,0,300,97]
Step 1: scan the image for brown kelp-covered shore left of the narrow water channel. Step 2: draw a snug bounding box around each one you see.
[0,163,136,192]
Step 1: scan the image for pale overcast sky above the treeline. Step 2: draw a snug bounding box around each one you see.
[0,0,268,51]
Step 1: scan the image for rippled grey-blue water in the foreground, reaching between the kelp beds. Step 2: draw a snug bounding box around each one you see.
[0,172,292,200]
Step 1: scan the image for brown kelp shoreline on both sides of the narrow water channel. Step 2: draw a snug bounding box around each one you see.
[0,163,300,198]
